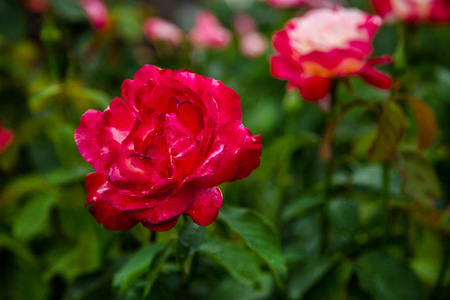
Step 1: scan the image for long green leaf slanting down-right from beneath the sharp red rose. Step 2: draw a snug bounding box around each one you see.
[219,207,287,286]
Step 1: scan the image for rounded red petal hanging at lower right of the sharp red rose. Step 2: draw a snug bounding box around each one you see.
[184,187,222,226]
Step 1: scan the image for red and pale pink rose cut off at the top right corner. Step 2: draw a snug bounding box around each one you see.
[372,0,450,22]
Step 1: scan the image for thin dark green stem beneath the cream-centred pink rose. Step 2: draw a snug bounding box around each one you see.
[321,80,338,254]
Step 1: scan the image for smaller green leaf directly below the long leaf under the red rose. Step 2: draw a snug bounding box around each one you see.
[200,239,261,286]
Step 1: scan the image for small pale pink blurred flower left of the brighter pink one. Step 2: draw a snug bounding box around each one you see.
[144,17,183,45]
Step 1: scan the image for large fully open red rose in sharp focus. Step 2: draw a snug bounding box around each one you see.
[74,65,261,231]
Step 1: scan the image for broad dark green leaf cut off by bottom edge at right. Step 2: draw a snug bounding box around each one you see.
[356,252,425,300]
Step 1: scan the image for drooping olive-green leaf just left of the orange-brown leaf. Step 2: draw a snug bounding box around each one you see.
[369,101,408,162]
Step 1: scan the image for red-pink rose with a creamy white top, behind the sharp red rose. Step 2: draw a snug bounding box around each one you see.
[270,7,391,101]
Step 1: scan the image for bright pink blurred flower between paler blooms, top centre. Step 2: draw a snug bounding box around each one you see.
[189,11,231,50]
